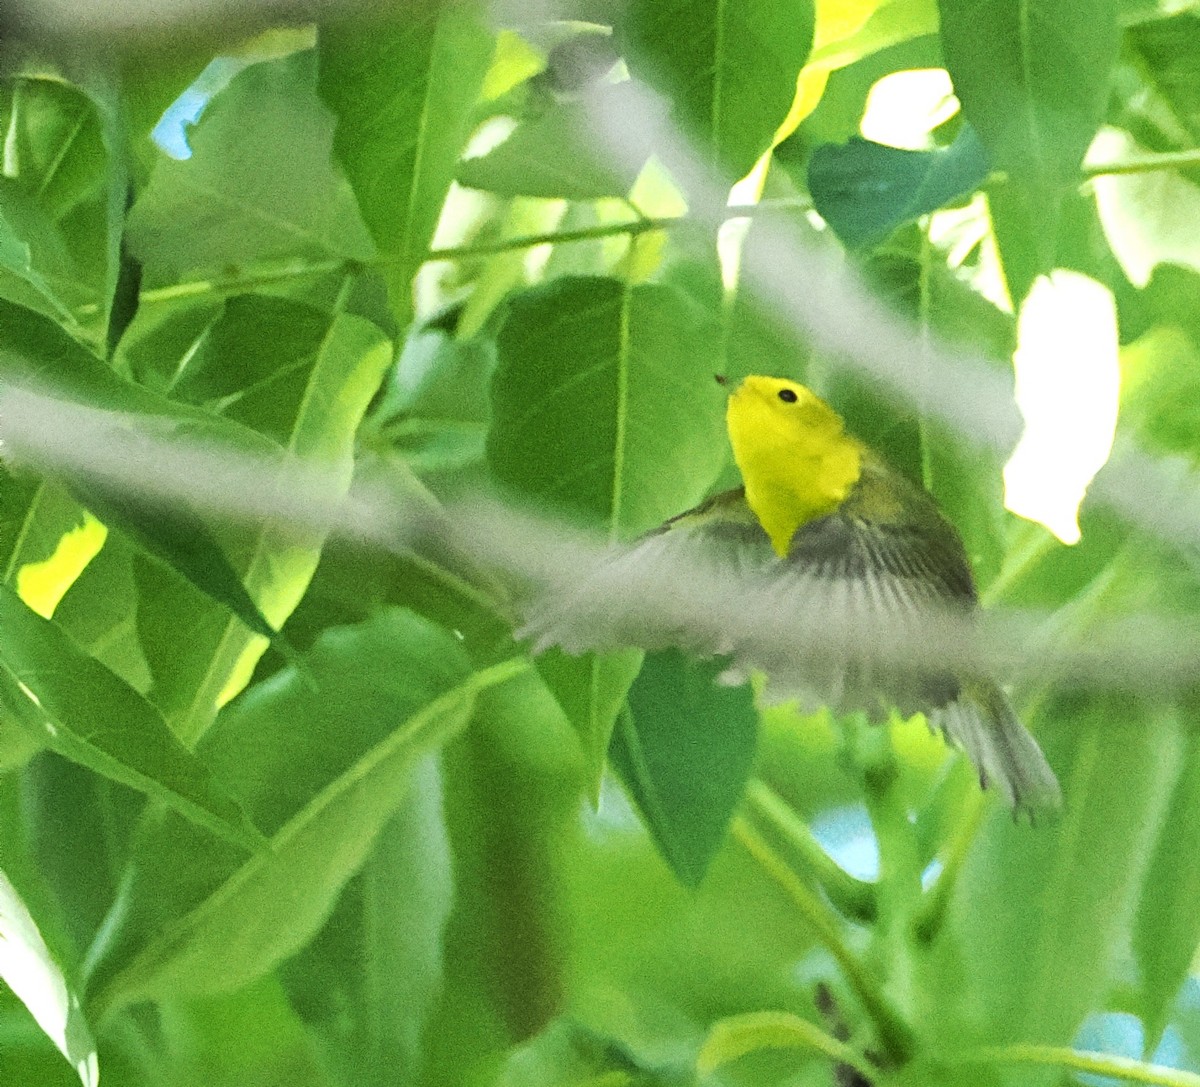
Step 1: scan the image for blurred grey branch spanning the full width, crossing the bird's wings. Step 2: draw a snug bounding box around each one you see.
[7,388,1200,693]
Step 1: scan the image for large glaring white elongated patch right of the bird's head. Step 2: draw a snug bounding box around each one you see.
[1004,269,1120,544]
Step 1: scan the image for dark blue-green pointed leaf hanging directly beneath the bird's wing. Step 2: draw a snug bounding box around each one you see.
[611,649,758,887]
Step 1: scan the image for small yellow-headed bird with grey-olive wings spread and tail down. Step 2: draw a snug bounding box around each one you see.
[526,377,1061,811]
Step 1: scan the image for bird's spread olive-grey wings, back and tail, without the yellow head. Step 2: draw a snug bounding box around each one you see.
[523,455,1058,810]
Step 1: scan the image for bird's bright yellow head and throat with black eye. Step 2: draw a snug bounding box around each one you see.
[725,377,863,557]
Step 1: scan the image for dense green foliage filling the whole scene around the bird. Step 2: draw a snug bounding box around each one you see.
[0,0,1200,1087]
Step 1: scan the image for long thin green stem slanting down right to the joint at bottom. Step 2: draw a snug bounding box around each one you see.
[730,816,914,1064]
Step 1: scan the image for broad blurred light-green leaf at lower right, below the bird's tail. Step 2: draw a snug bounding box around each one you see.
[934,693,1182,1049]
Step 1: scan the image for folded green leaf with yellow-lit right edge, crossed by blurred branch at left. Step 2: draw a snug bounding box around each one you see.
[106,285,391,740]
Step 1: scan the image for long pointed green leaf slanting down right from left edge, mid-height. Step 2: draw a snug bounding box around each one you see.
[0,585,259,849]
